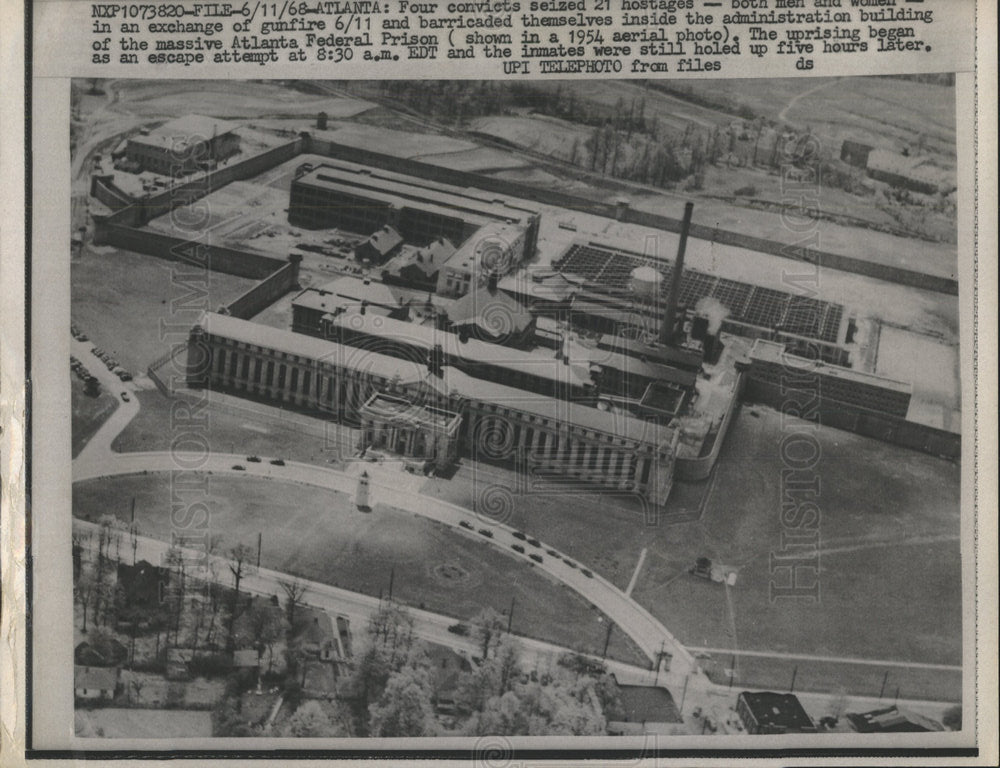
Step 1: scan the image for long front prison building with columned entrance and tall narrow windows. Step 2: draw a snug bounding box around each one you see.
[187,313,679,505]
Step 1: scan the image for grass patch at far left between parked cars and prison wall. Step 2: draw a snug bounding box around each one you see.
[71,247,256,372]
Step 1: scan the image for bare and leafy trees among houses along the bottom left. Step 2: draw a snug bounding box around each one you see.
[73,515,615,736]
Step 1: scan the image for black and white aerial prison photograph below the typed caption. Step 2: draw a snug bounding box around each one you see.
[64,69,968,744]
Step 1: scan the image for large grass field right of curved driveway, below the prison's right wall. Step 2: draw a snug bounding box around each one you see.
[426,408,961,684]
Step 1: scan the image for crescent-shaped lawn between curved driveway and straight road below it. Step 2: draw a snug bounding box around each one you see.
[73,475,645,664]
